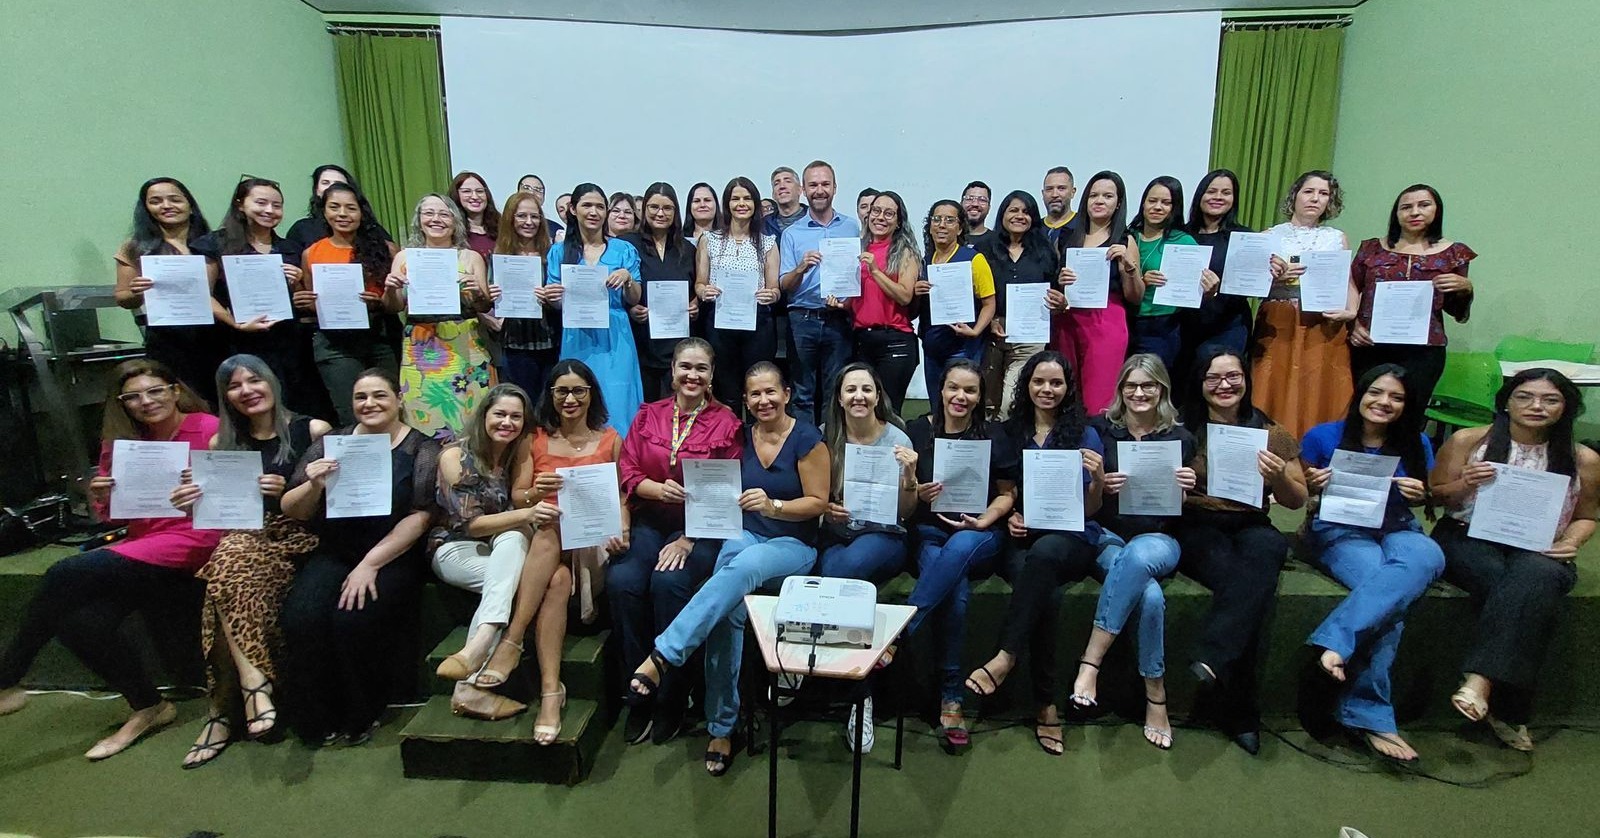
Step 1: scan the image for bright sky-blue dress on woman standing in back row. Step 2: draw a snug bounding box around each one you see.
[550,238,645,437]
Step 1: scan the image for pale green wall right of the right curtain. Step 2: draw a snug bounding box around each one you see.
[1334,0,1600,356]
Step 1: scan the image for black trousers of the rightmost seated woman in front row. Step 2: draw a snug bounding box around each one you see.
[1434,518,1578,724]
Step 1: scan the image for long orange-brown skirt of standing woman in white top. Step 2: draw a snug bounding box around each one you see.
[1250,301,1355,438]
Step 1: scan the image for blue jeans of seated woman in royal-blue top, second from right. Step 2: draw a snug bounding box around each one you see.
[1306,520,1445,734]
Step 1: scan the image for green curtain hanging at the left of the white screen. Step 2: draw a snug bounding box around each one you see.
[333,34,450,240]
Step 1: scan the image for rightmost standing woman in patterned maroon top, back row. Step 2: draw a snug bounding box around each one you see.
[1350,184,1478,406]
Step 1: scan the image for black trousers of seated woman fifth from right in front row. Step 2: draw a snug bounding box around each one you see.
[1000,533,1099,707]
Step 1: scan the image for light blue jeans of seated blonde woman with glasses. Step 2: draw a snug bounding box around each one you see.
[1094,529,1178,678]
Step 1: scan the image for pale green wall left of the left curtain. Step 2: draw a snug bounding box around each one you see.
[0,0,344,300]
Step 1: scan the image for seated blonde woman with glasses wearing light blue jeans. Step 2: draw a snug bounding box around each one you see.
[1067,353,1195,750]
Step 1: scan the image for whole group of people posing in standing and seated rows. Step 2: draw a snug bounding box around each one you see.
[0,162,1600,774]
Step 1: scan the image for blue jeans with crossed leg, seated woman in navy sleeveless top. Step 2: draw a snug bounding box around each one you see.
[656,531,816,739]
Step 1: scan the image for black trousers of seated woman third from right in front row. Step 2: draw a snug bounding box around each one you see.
[1173,513,1290,728]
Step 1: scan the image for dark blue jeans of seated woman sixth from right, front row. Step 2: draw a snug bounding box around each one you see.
[906,525,1000,702]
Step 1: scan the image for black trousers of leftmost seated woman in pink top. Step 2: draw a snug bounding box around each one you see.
[0,547,205,710]
